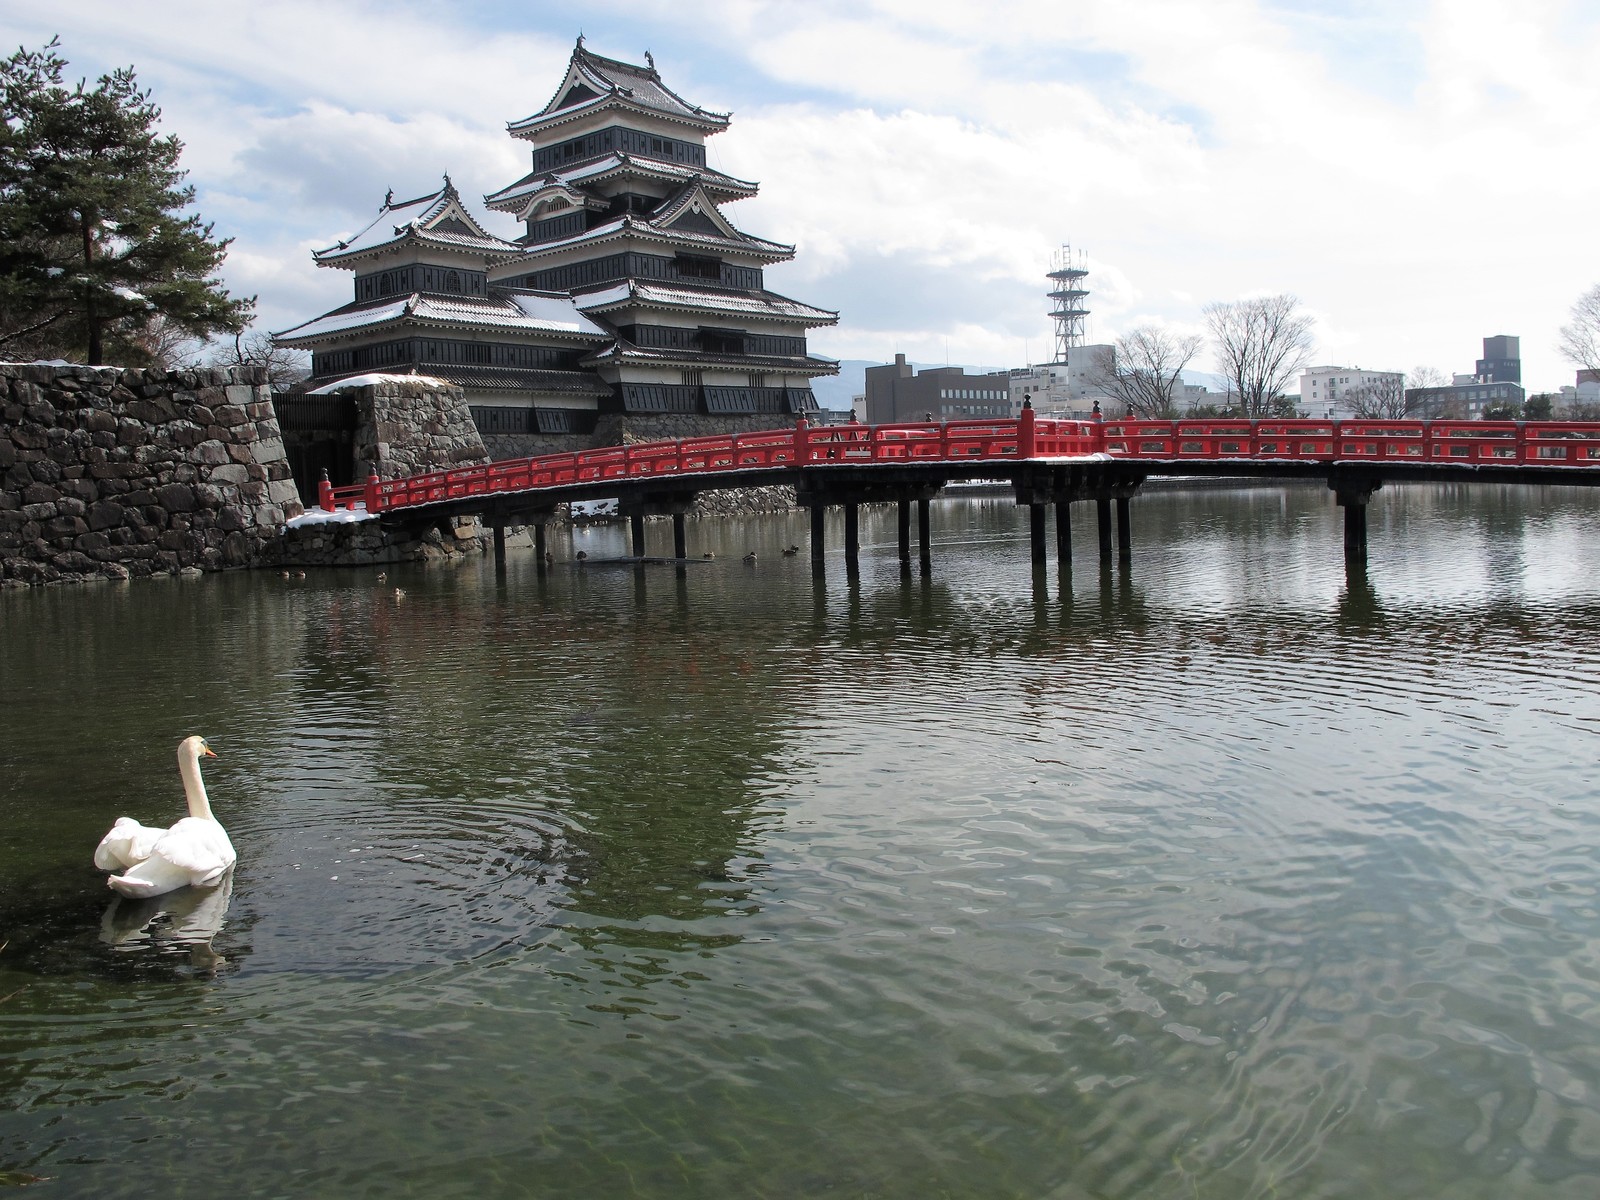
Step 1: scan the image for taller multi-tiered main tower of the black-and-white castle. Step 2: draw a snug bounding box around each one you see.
[483,38,838,424]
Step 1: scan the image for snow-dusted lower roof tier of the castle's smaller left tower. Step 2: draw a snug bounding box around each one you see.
[272,288,611,347]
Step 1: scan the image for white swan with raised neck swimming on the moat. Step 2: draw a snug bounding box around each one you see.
[94,736,238,899]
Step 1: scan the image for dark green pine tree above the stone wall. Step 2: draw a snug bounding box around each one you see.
[0,38,254,365]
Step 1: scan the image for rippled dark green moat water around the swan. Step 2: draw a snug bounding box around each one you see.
[0,488,1600,1200]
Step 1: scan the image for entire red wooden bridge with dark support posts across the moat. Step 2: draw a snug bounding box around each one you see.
[318,410,1600,568]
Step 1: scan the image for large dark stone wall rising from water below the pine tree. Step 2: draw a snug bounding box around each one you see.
[0,363,301,587]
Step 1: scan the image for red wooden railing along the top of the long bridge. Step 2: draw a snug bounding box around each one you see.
[317,410,1600,512]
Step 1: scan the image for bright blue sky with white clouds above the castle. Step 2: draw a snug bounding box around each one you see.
[0,0,1600,390]
